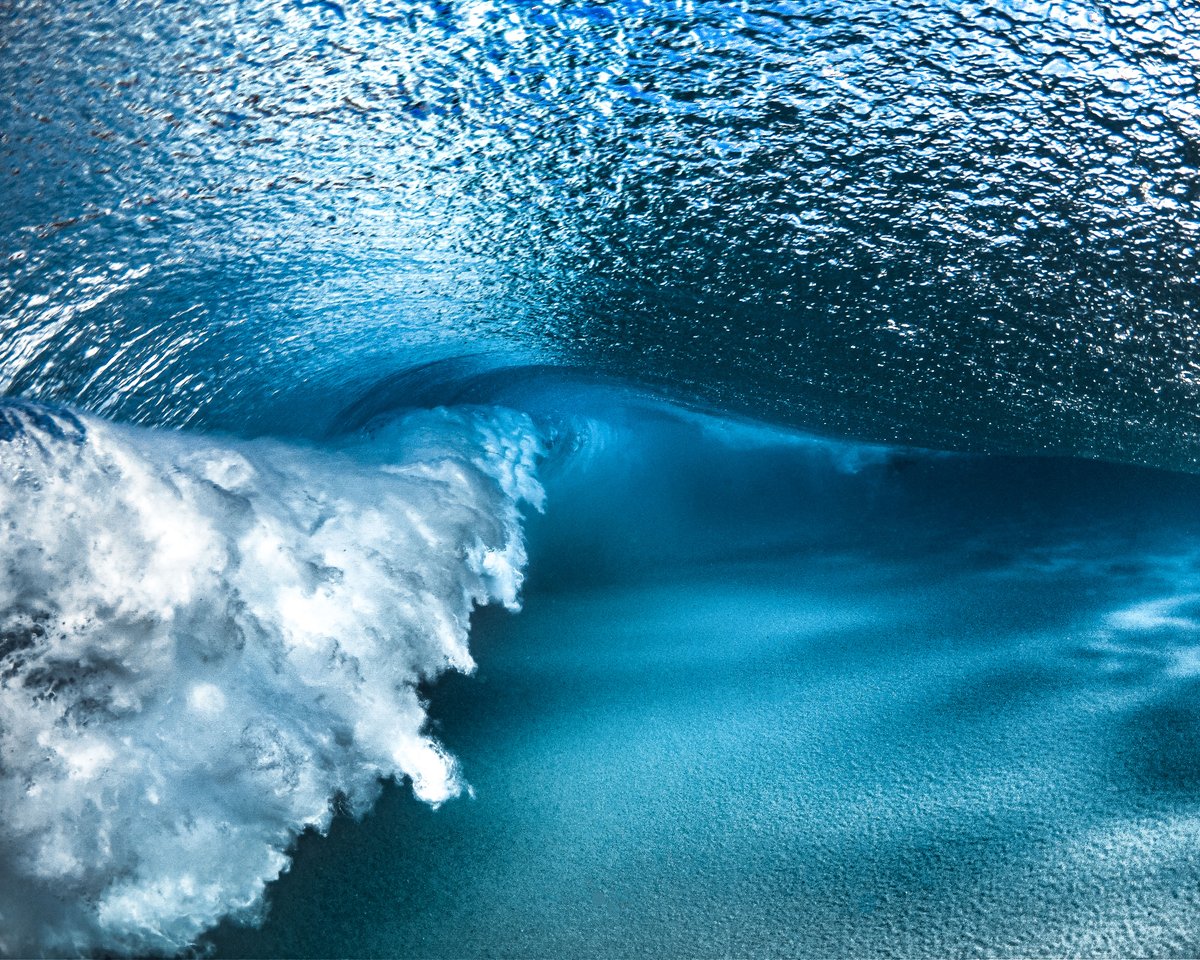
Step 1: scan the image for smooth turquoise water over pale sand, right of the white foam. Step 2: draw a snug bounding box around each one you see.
[211,408,1200,956]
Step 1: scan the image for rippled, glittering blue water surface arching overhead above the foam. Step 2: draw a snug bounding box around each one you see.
[0,0,1200,469]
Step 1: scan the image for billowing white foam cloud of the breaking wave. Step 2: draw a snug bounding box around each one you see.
[0,404,542,955]
